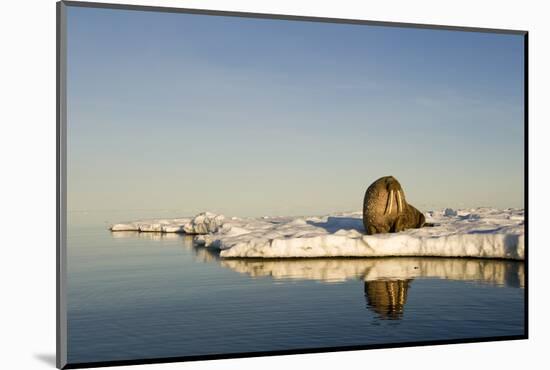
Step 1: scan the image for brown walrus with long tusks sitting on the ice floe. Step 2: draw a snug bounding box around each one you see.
[363,176,434,235]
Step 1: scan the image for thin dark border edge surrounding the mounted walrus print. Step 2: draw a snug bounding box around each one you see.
[56,0,529,369]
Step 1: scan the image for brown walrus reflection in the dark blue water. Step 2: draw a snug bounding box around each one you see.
[364,279,412,320]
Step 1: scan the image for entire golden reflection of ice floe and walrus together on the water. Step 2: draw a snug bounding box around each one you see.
[112,231,524,320]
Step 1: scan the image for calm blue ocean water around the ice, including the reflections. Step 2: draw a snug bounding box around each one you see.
[68,214,525,363]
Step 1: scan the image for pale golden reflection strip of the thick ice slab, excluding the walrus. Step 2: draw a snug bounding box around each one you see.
[219,257,524,287]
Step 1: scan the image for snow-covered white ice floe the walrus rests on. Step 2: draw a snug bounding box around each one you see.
[111,208,525,260]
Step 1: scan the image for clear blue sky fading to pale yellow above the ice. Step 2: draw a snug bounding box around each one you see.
[67,7,524,215]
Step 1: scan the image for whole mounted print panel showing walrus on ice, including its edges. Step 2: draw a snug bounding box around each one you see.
[57,2,528,368]
